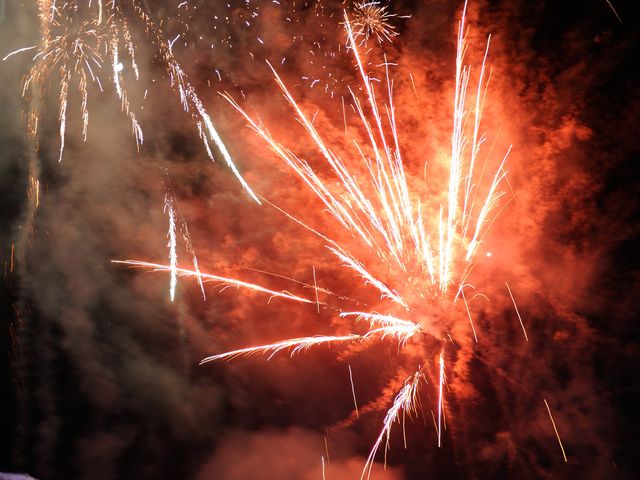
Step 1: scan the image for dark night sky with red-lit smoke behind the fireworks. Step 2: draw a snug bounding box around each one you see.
[0,0,640,480]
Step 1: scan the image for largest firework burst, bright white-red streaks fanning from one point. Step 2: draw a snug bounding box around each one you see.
[119,0,524,478]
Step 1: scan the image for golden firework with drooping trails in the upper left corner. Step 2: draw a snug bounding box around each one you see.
[4,0,260,199]
